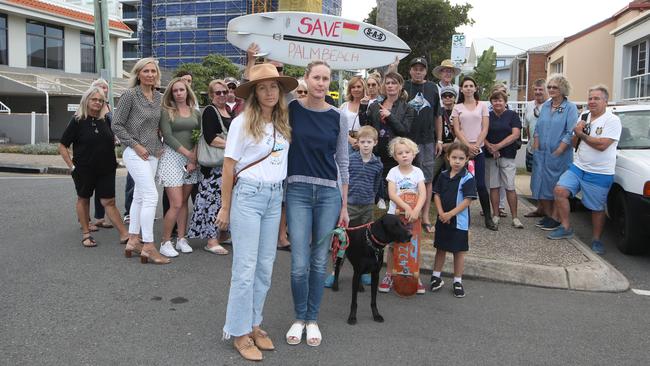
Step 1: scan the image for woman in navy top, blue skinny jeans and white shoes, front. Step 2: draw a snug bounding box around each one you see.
[286,61,349,347]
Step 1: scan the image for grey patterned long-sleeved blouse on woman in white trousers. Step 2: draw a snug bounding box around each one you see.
[113,85,162,156]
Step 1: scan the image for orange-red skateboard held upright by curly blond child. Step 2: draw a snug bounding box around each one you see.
[392,192,422,297]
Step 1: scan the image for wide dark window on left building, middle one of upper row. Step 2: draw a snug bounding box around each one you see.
[27,20,64,70]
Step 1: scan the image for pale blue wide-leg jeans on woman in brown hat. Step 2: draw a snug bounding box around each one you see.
[223,178,282,339]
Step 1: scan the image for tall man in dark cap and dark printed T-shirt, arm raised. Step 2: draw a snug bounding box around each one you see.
[389,56,442,232]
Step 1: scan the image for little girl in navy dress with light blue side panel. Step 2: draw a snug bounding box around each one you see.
[431,141,477,297]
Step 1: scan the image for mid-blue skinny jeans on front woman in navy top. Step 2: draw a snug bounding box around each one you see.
[287,183,341,321]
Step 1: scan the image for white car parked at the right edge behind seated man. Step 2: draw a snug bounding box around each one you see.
[607,104,650,254]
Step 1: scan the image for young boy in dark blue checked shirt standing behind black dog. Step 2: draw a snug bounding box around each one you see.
[325,126,384,287]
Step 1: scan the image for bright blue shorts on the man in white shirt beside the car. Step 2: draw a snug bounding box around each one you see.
[557,165,614,211]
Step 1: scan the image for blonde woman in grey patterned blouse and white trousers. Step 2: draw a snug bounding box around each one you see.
[113,58,170,264]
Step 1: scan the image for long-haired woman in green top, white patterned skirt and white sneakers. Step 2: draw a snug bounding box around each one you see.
[158,77,201,257]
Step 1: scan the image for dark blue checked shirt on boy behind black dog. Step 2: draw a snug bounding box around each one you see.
[348,151,384,206]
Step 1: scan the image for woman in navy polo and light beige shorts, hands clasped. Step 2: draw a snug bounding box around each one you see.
[485,91,524,229]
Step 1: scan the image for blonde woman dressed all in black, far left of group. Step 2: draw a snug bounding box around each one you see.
[59,87,129,247]
